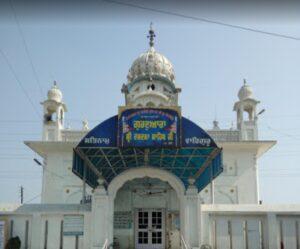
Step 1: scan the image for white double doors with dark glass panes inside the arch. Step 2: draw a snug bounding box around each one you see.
[135,209,165,249]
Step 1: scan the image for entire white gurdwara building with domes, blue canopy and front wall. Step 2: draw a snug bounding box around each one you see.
[0,29,300,249]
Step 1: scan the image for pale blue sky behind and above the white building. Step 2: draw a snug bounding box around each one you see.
[0,1,300,204]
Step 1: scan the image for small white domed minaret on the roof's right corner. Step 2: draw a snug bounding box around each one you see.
[233,79,260,140]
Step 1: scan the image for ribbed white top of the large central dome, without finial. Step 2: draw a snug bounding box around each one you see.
[127,47,175,83]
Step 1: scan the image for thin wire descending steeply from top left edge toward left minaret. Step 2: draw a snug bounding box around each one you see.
[9,0,43,98]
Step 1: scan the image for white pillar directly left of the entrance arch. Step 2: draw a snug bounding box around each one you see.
[91,178,114,249]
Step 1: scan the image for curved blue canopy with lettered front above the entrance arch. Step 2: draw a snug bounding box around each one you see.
[72,108,223,191]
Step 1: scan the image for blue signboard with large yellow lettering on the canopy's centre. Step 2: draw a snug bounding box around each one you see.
[119,108,181,147]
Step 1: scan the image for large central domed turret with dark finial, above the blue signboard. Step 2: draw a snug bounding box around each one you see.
[122,26,181,107]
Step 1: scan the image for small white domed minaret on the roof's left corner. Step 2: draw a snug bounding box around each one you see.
[41,81,67,141]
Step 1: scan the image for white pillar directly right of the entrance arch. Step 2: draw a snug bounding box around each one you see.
[184,179,199,248]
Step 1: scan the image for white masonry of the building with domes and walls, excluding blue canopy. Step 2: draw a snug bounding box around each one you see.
[0,31,300,249]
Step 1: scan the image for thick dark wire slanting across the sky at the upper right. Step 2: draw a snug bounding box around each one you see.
[101,0,300,41]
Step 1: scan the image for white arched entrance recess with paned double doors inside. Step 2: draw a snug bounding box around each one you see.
[108,167,184,249]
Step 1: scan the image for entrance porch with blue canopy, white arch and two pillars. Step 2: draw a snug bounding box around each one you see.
[72,108,223,249]
